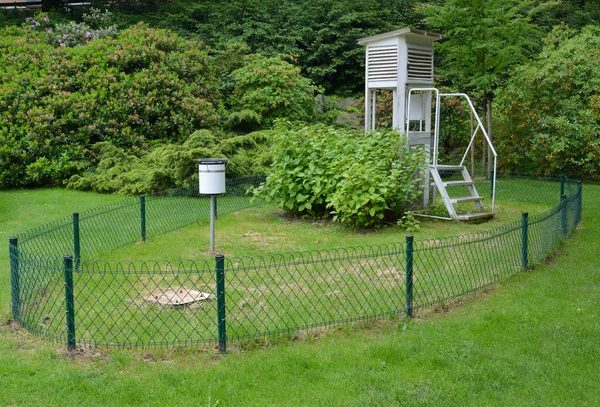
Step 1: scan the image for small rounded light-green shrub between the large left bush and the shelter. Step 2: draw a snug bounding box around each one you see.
[231,55,316,125]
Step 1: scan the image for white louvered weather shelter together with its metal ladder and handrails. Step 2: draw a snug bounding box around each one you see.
[358,28,497,220]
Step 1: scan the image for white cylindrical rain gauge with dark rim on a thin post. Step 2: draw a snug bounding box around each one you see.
[196,158,227,252]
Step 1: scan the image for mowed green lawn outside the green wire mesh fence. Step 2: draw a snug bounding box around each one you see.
[0,185,600,406]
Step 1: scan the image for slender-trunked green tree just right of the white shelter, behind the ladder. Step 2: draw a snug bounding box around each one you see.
[417,0,552,175]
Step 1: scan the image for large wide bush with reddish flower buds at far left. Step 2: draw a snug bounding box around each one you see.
[0,19,222,188]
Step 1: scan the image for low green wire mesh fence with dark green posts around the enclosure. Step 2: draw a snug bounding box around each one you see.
[9,177,582,351]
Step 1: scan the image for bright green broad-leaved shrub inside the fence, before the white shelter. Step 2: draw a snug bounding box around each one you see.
[255,124,425,227]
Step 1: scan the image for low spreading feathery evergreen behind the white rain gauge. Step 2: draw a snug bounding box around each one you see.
[67,130,271,194]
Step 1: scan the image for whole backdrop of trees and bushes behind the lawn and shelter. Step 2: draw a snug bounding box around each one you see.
[0,0,600,206]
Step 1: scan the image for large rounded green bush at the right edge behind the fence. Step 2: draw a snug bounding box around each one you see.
[499,26,600,179]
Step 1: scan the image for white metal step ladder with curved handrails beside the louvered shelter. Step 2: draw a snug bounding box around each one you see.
[406,88,498,220]
